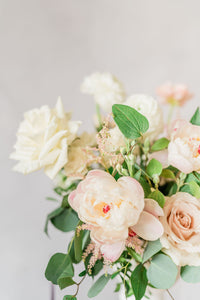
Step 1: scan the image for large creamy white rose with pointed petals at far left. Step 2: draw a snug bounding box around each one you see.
[10,98,80,179]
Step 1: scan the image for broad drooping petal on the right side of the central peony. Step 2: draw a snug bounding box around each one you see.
[131,211,164,241]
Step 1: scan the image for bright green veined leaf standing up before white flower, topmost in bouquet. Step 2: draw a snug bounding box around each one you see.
[112,104,149,140]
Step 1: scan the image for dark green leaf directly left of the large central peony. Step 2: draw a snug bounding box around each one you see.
[51,208,79,232]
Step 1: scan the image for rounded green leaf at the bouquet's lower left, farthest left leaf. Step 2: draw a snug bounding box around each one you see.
[45,253,74,284]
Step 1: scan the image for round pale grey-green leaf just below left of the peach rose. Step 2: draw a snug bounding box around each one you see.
[147,253,178,289]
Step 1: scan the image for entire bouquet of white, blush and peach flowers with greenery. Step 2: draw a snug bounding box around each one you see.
[11,73,200,300]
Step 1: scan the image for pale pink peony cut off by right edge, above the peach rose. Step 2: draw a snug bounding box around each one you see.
[168,120,200,174]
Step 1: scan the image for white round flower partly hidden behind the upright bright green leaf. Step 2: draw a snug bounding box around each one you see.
[124,94,164,141]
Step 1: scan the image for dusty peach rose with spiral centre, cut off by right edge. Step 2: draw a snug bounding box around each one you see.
[160,192,200,266]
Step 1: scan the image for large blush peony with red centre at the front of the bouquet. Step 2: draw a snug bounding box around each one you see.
[69,170,163,261]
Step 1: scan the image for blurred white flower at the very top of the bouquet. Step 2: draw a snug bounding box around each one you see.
[81,73,125,112]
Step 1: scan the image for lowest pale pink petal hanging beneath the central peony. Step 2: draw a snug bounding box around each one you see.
[100,241,125,262]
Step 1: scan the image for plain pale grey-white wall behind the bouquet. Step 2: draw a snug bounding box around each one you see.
[0,0,200,300]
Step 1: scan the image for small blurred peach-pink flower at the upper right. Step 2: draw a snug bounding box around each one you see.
[157,83,193,106]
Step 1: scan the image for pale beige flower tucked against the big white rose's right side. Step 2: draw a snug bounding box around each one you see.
[64,132,96,178]
